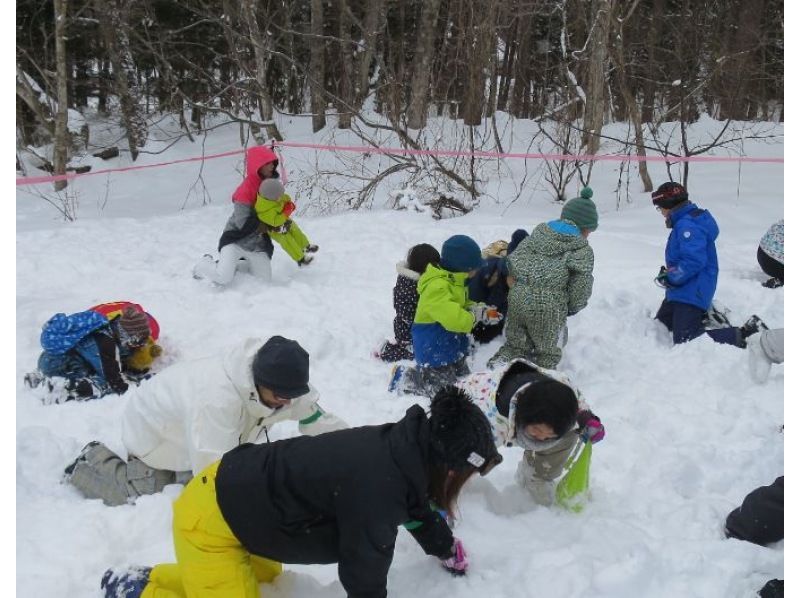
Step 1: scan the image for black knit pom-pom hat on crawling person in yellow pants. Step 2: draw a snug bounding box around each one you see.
[430,386,497,471]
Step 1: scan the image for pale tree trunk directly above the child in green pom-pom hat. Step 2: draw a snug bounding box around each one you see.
[583,0,614,154]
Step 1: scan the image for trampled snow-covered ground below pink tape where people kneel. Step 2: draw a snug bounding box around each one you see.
[15,113,792,598]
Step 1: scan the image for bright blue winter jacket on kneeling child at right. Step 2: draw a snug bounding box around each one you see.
[664,203,719,310]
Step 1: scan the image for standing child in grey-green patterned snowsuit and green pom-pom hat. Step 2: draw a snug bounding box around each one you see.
[489,187,597,369]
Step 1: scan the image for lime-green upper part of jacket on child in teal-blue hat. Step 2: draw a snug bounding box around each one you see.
[414,264,475,333]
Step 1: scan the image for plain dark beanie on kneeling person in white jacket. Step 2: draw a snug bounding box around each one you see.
[253,336,309,399]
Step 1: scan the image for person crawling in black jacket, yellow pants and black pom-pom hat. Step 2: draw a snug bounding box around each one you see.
[101,388,502,598]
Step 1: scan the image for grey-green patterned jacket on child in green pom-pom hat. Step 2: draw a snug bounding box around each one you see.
[508,220,594,317]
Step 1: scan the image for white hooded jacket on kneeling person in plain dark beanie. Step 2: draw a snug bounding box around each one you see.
[122,338,347,475]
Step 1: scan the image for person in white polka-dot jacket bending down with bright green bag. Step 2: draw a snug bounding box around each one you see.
[456,359,605,505]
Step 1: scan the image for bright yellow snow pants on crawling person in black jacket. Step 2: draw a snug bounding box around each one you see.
[142,461,283,598]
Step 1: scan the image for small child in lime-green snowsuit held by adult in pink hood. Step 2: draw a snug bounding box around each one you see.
[255,179,319,266]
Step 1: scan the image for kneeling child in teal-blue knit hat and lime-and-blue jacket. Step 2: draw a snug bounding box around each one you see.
[389,235,502,397]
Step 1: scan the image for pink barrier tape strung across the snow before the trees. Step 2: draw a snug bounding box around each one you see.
[17,141,783,186]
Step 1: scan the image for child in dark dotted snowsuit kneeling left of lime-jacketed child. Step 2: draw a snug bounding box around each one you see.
[377,243,440,361]
